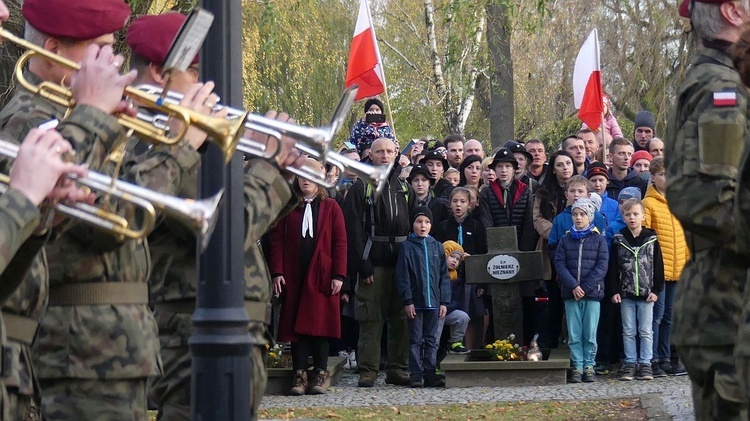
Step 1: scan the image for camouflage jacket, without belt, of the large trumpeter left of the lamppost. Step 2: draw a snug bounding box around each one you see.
[0,72,161,380]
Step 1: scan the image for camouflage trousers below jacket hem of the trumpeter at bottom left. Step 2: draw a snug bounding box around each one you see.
[41,378,147,421]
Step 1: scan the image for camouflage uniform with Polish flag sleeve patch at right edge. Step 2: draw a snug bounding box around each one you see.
[665,41,750,420]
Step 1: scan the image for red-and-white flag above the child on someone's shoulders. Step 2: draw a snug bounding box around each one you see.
[346,0,385,100]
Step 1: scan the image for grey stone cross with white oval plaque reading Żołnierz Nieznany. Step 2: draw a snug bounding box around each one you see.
[465,226,544,345]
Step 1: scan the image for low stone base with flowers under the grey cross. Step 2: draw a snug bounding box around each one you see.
[440,349,570,387]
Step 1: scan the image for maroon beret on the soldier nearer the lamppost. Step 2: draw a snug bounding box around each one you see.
[125,12,198,65]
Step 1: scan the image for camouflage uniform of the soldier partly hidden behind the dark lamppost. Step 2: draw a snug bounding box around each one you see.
[144,152,292,420]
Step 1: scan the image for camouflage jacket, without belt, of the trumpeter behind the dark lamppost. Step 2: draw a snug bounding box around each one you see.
[149,156,292,346]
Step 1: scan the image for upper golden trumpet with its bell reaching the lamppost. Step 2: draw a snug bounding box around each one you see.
[0,28,244,163]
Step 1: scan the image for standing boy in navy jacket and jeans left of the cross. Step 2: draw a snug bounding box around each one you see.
[396,206,451,387]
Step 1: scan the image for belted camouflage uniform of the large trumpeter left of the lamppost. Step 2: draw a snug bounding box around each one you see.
[0,72,166,419]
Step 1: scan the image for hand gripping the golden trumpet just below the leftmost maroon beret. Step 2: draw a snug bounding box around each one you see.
[70,44,138,116]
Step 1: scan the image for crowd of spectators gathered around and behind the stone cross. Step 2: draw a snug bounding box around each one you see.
[290,94,689,393]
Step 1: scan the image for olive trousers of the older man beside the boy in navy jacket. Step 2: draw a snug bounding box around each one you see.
[354,267,409,373]
